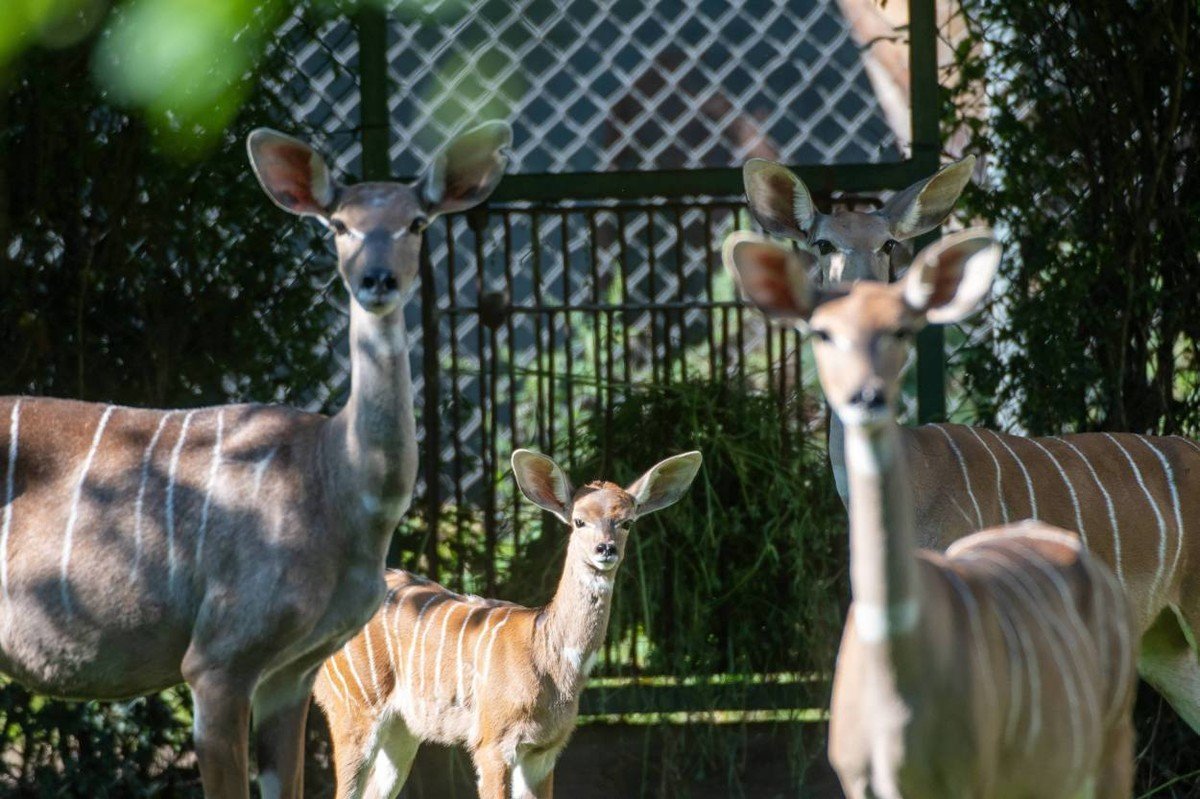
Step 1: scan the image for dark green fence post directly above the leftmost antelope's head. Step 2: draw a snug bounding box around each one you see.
[358,4,391,180]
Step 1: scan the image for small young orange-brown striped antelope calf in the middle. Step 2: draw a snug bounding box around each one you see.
[316,450,701,799]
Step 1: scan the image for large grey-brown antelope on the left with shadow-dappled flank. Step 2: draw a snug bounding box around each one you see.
[0,122,511,798]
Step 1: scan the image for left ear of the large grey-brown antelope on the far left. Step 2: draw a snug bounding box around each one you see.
[246,127,337,217]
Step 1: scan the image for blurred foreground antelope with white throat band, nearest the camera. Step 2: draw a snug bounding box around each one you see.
[725,225,1136,799]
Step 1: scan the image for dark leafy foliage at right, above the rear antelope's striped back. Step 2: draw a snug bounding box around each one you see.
[947,0,1200,433]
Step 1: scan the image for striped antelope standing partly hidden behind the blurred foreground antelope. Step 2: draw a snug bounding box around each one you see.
[745,157,1200,732]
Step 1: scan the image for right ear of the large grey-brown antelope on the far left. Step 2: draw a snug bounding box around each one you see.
[420,121,512,214]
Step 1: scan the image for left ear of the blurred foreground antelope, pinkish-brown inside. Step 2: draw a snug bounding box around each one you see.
[721,230,817,324]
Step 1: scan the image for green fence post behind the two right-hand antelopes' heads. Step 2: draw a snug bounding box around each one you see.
[908,0,946,423]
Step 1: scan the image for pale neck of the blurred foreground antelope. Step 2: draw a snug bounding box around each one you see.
[845,421,920,642]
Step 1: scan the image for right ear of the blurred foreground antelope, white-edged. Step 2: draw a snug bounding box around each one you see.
[901,228,1001,324]
